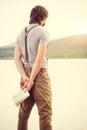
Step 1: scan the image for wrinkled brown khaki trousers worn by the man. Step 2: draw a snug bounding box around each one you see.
[18,67,52,130]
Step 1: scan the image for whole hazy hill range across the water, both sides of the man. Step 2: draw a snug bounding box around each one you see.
[0,35,87,59]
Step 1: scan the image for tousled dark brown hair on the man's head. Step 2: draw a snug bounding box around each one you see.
[29,5,48,25]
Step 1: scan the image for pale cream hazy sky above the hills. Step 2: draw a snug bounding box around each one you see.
[0,0,87,46]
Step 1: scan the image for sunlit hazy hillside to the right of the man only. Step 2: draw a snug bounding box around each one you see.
[47,35,87,58]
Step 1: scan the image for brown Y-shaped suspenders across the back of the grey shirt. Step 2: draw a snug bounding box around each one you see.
[25,25,38,62]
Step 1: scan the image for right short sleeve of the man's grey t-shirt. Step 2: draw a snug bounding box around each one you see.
[39,30,50,44]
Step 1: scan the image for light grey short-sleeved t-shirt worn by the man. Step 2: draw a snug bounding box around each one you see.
[17,24,49,68]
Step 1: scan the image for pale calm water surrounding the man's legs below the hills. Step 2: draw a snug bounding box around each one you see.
[0,59,87,130]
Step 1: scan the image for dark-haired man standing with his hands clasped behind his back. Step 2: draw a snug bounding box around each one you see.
[14,6,52,130]
